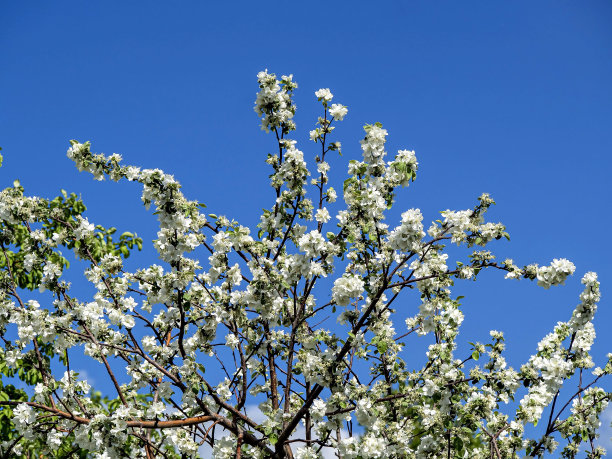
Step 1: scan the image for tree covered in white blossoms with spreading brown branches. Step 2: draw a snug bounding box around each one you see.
[0,72,612,459]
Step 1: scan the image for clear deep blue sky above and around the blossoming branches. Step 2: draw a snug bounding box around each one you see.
[0,1,612,450]
